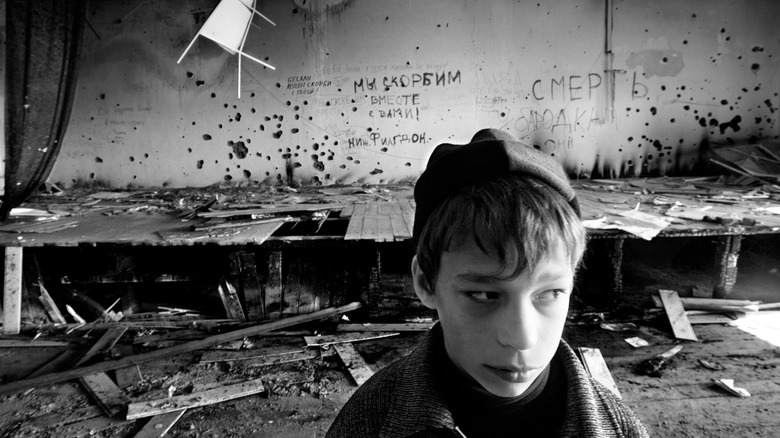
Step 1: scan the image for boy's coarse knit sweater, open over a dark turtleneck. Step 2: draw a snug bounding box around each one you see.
[326,325,648,438]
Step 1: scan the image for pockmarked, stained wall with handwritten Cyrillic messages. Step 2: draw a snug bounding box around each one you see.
[45,0,780,188]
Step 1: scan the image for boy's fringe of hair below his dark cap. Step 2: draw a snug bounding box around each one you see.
[417,173,587,291]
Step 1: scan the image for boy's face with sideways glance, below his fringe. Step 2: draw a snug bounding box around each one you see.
[412,240,574,397]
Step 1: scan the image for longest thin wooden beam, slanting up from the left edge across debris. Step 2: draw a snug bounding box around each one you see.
[0,302,361,395]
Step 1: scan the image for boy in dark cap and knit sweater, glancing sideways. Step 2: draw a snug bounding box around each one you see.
[327,129,647,438]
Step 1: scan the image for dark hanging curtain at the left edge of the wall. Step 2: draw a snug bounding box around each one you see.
[0,0,86,220]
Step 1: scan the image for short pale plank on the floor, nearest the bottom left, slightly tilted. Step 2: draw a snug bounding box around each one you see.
[126,379,265,420]
